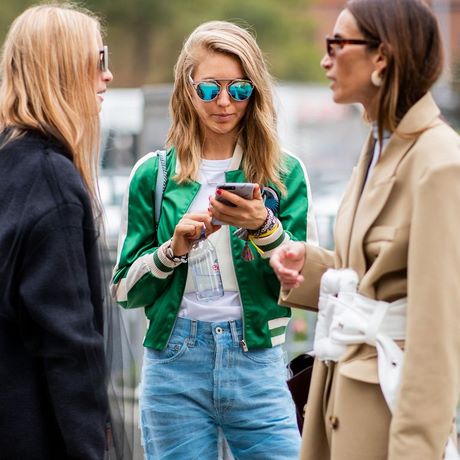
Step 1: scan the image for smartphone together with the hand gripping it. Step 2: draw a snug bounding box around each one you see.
[209,182,267,230]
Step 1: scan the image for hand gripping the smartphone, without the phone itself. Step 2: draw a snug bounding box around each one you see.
[209,184,267,230]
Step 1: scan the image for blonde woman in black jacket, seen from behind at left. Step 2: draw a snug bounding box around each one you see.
[0,5,112,460]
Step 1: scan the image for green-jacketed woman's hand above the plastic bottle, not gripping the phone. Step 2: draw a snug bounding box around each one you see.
[171,212,220,256]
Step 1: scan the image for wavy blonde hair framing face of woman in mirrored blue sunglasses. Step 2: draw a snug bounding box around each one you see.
[166,21,285,192]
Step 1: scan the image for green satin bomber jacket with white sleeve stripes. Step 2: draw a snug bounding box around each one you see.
[111,148,317,350]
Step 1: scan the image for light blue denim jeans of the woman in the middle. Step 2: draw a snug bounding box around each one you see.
[140,318,300,460]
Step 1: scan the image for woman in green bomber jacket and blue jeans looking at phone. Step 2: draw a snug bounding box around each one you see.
[112,21,316,460]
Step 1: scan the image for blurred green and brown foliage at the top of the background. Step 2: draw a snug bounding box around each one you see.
[0,0,322,86]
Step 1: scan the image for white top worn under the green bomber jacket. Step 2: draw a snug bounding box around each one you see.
[179,158,241,322]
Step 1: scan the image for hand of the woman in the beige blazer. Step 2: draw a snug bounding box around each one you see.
[270,241,306,290]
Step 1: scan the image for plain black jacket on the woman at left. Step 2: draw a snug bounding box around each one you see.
[0,132,108,460]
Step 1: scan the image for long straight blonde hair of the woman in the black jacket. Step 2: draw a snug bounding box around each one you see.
[0,4,100,210]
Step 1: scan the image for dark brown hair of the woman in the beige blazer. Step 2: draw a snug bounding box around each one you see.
[346,0,443,134]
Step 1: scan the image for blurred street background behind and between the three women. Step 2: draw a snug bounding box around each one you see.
[0,0,460,458]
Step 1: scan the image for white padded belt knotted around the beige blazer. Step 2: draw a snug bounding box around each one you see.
[313,269,460,460]
